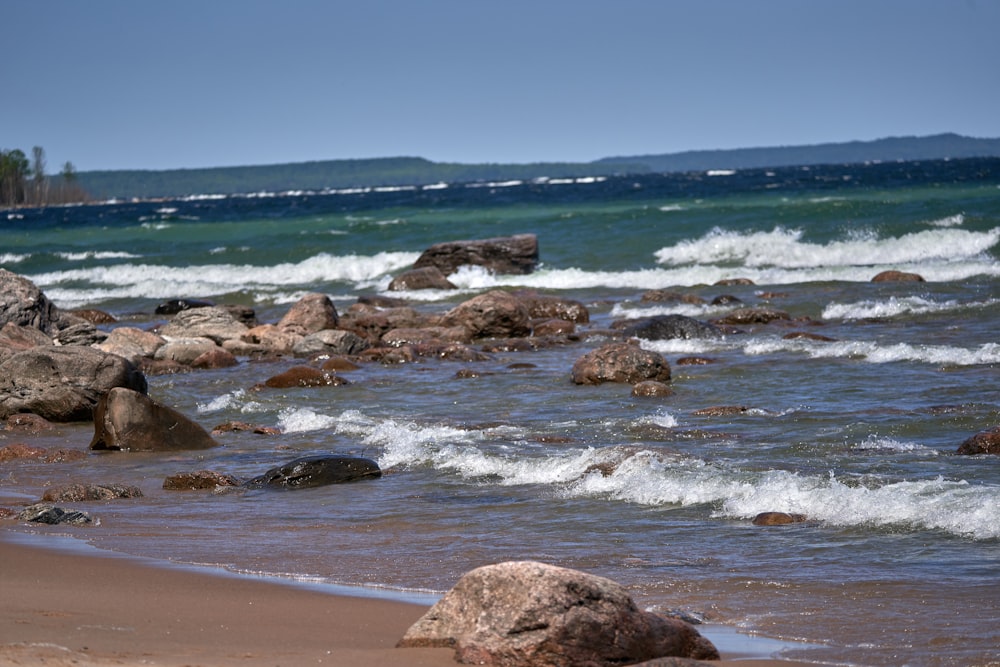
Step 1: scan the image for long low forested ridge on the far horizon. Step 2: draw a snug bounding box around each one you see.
[76,133,1000,199]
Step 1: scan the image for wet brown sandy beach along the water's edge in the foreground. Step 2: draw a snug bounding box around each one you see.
[0,529,815,667]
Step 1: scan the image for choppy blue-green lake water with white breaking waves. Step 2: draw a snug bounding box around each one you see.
[0,160,1000,665]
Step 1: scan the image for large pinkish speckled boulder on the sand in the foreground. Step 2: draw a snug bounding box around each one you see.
[398,561,719,667]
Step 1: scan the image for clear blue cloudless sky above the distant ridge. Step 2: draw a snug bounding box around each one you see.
[0,0,1000,173]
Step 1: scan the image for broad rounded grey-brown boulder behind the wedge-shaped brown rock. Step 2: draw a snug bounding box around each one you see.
[0,347,146,422]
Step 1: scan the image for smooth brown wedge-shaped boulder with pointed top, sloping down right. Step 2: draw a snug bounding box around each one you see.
[90,388,218,452]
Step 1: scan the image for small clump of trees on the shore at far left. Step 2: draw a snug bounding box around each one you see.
[0,146,90,206]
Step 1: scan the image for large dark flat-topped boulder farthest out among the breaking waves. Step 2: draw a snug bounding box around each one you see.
[413,234,538,276]
